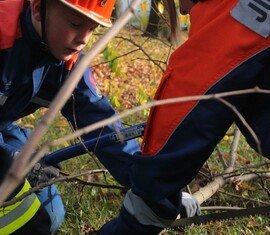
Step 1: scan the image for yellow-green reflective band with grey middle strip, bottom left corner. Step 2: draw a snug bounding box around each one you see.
[0,181,41,235]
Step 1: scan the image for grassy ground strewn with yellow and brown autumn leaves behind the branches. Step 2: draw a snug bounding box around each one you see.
[22,30,270,235]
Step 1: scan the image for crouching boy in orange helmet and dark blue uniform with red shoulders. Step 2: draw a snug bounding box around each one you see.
[0,0,139,232]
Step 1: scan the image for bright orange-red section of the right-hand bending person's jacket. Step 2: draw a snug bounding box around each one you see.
[142,0,270,156]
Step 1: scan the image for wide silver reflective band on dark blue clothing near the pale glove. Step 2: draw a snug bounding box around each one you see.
[124,190,174,228]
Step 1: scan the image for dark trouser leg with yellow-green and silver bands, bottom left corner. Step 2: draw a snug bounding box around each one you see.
[0,147,51,235]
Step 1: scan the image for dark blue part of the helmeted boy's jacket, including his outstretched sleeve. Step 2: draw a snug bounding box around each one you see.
[0,8,139,187]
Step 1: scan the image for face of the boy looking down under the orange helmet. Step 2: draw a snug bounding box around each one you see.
[38,0,98,61]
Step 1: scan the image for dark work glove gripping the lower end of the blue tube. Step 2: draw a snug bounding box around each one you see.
[27,159,60,187]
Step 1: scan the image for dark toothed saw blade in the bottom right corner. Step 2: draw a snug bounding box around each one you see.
[171,206,270,228]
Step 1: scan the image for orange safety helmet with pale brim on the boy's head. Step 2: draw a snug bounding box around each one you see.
[59,0,115,27]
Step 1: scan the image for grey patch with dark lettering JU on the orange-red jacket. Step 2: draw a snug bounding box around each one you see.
[231,0,270,38]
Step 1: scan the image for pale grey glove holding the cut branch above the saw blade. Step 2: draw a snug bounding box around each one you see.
[180,192,201,218]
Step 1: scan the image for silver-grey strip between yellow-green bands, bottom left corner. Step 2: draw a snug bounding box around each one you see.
[0,193,37,228]
